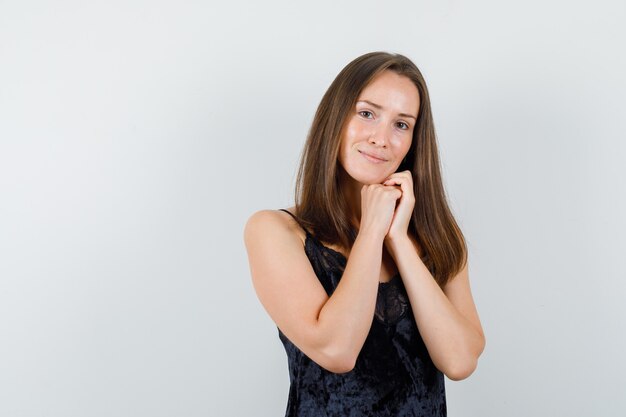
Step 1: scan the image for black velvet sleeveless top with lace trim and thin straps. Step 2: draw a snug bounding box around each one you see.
[277,209,447,417]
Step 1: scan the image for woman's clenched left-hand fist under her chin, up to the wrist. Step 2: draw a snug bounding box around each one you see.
[359,184,402,239]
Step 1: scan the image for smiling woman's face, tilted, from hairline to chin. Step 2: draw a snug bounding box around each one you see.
[339,70,419,184]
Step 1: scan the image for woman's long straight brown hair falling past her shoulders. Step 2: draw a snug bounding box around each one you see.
[295,52,467,288]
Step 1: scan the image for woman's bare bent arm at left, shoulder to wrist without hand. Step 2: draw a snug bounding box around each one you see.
[244,210,384,373]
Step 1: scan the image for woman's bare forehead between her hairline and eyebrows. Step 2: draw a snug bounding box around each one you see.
[357,70,419,115]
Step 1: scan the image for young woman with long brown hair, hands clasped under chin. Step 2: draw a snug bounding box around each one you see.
[244,52,485,417]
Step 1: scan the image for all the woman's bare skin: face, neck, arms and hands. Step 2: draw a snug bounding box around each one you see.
[245,67,485,380]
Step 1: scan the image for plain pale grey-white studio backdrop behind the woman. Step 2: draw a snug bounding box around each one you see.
[0,0,626,417]
